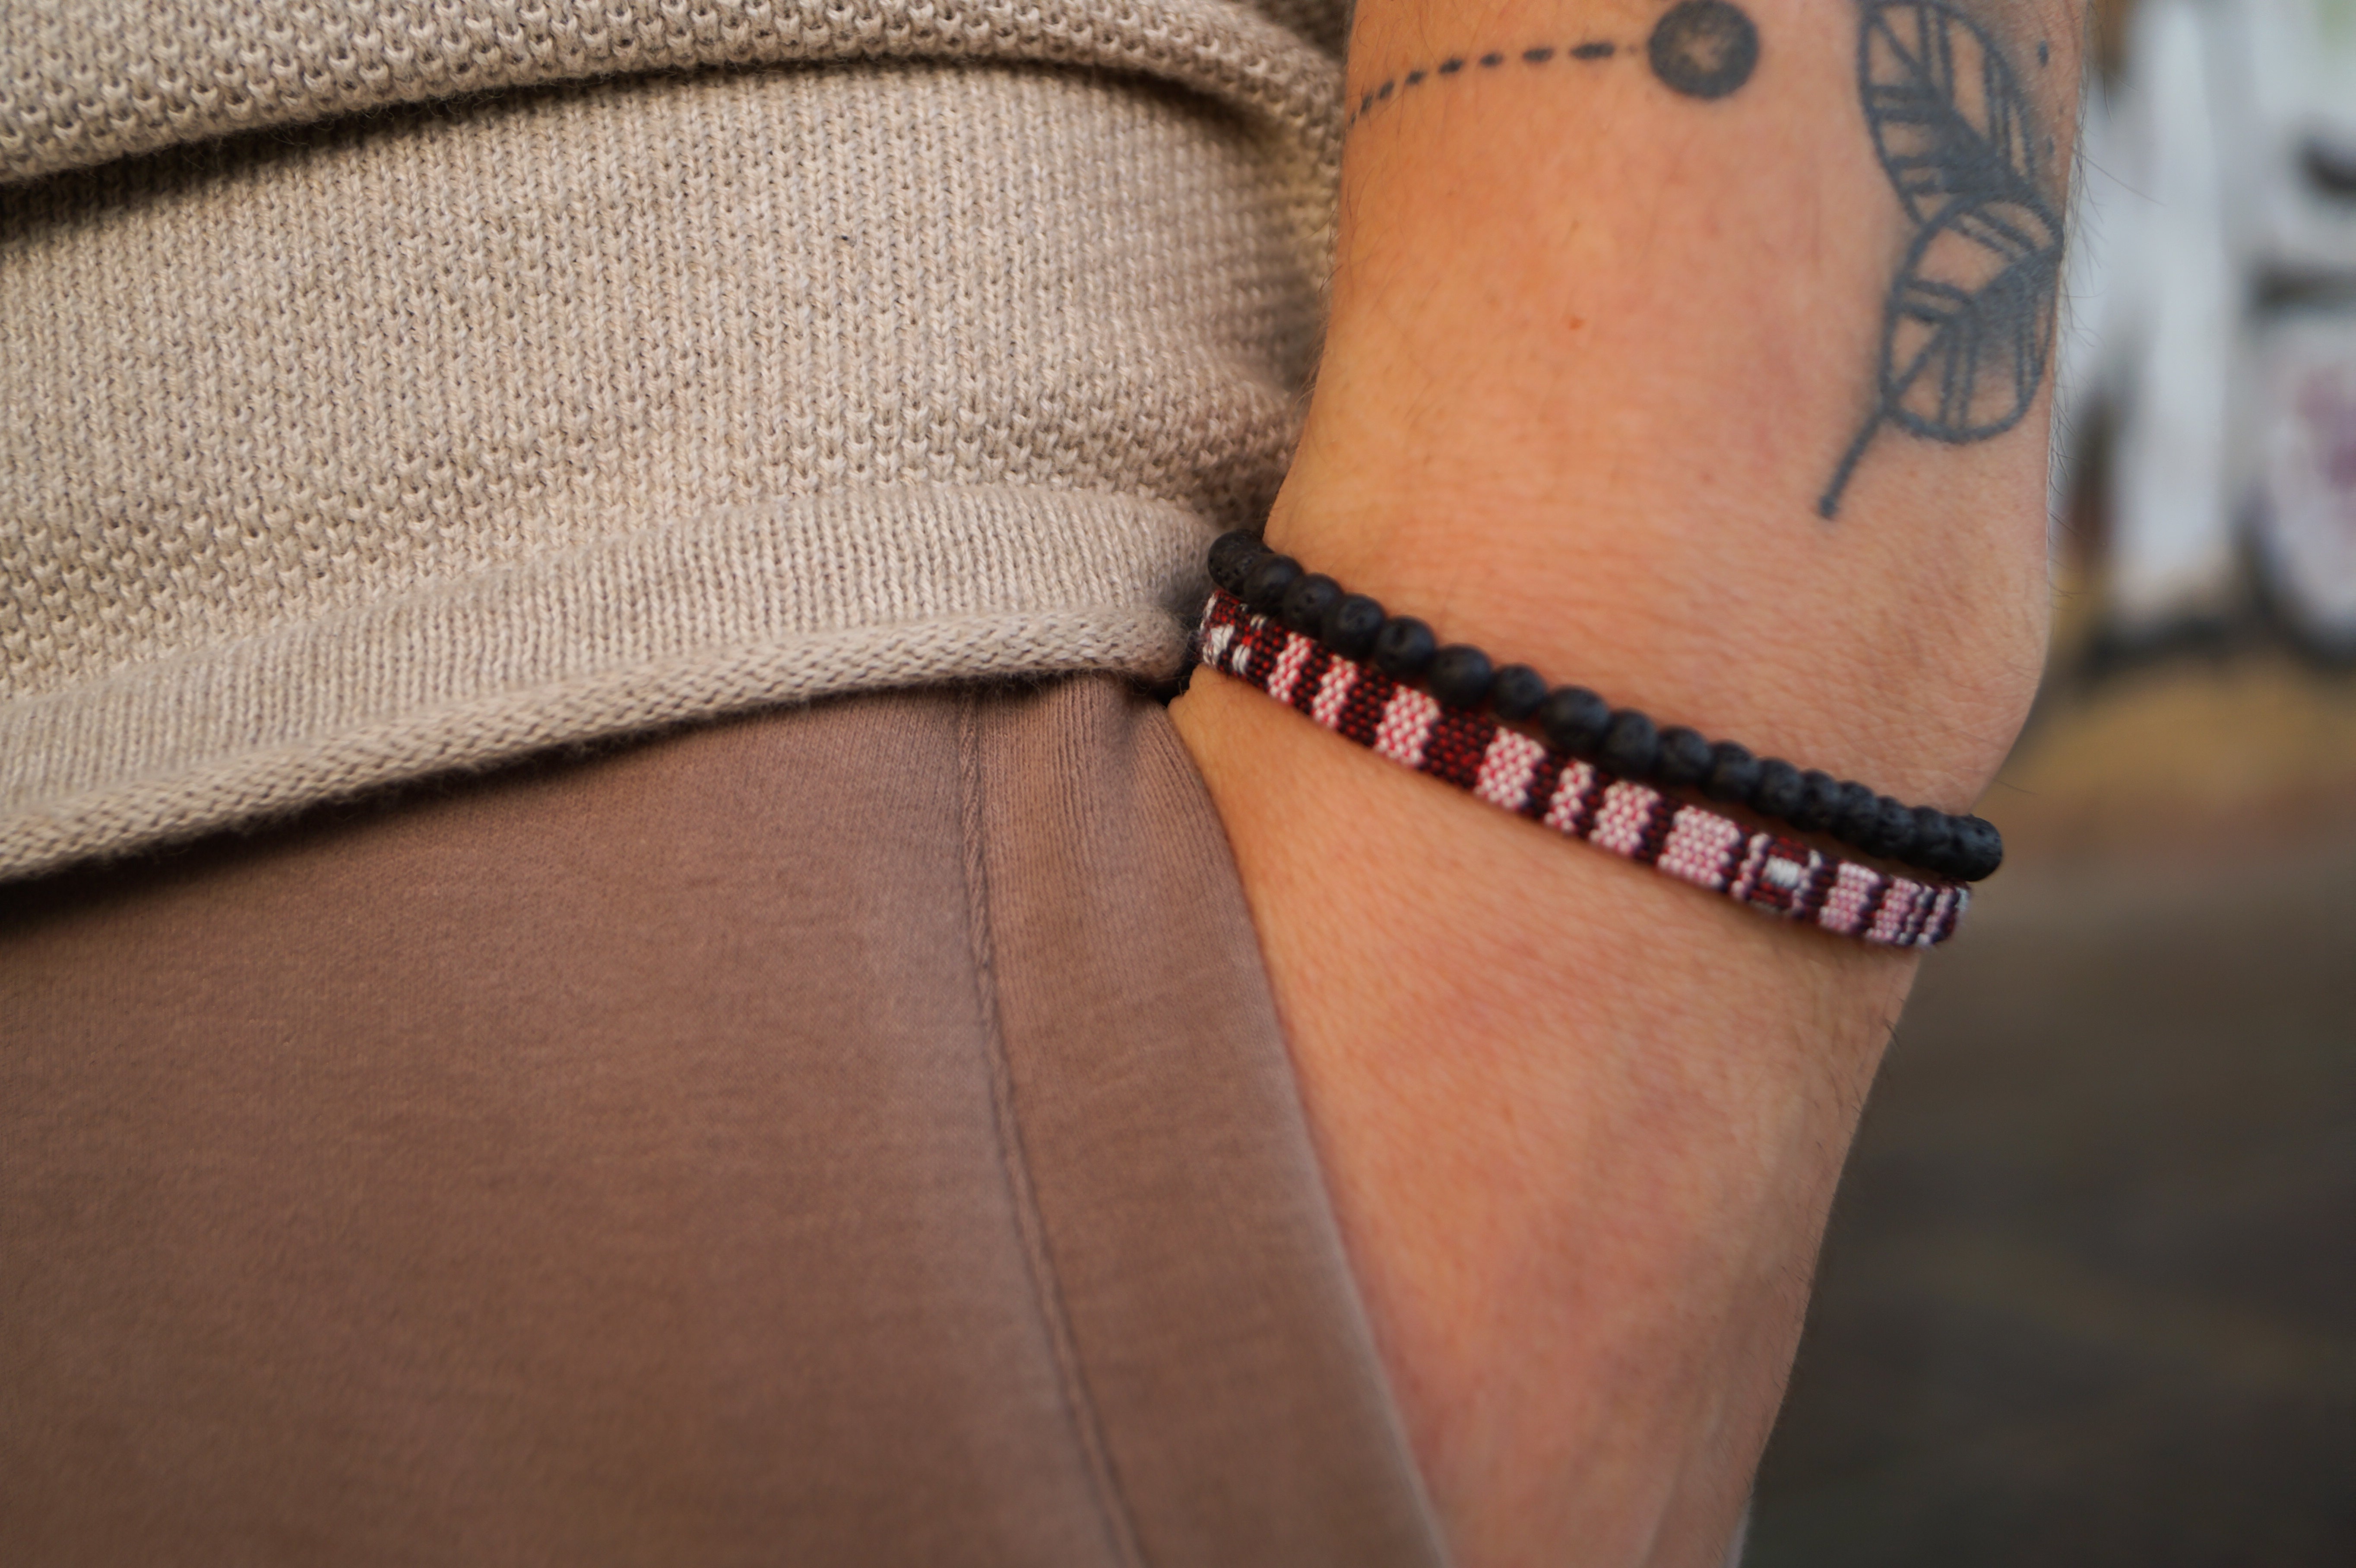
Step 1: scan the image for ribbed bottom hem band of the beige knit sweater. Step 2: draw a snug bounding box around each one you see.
[0,487,1211,878]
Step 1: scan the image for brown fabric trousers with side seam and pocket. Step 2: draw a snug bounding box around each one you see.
[0,678,1437,1566]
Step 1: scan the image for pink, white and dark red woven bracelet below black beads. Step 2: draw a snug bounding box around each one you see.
[1197,588,1972,946]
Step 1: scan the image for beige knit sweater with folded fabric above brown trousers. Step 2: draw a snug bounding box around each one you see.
[0,0,1343,876]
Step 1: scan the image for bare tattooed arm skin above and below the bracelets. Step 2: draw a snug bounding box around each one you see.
[1173,0,2080,1568]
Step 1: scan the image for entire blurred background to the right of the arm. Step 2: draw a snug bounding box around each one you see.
[1748,0,2356,1568]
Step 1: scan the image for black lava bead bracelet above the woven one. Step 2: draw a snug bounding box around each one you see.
[1211,530,2005,883]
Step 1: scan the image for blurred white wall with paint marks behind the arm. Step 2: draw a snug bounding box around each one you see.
[2055,0,2356,652]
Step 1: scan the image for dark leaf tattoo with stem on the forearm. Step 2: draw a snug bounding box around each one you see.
[1817,0,2062,518]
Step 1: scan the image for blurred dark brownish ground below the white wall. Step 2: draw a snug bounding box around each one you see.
[1748,648,2356,1568]
